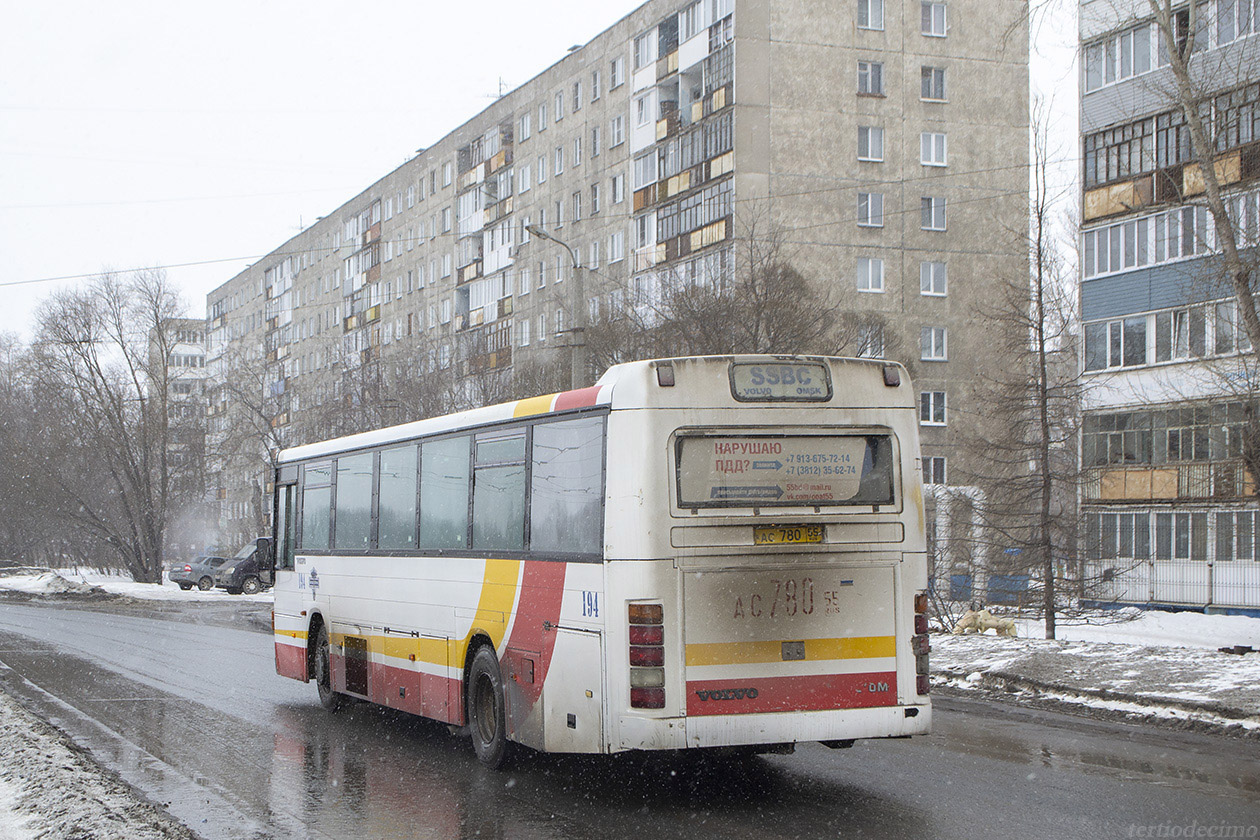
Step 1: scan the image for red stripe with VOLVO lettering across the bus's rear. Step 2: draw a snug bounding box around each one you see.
[687,671,897,717]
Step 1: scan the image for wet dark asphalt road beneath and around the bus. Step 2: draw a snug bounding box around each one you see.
[0,602,1260,840]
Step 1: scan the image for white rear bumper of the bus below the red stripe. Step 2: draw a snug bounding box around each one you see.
[619,703,932,749]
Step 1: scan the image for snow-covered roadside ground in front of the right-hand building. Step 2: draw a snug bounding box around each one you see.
[931,610,1260,737]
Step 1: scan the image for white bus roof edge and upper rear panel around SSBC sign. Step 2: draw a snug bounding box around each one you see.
[278,355,915,463]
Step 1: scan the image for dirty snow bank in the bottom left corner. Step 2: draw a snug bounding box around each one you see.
[0,693,197,840]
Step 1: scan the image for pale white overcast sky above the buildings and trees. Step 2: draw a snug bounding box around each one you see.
[0,0,1076,339]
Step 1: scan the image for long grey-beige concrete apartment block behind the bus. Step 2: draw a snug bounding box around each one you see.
[208,0,1028,551]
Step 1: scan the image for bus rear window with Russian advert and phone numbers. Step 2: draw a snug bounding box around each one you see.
[677,434,896,508]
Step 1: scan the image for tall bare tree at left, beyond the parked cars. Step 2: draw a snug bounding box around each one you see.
[33,272,200,583]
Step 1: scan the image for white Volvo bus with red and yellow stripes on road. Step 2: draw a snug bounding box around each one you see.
[273,356,931,767]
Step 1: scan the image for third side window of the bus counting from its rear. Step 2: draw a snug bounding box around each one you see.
[420,436,473,549]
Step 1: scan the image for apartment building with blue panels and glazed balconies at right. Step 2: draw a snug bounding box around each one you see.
[1080,0,1260,608]
